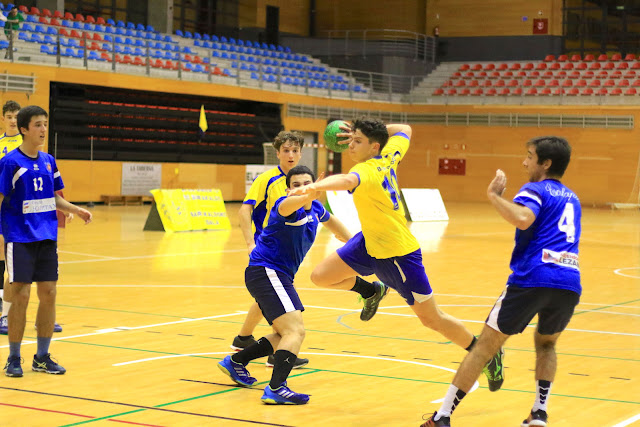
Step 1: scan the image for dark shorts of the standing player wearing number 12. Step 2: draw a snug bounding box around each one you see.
[4,240,58,283]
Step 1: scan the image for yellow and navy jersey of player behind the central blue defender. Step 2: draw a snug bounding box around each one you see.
[242,166,287,240]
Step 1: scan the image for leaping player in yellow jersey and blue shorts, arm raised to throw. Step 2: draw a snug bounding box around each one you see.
[289,118,504,391]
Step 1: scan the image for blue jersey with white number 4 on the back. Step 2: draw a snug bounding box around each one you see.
[508,179,582,294]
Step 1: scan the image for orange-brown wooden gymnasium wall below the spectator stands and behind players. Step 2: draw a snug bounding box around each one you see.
[1,64,640,205]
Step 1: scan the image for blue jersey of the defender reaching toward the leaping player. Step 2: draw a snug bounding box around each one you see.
[249,197,330,281]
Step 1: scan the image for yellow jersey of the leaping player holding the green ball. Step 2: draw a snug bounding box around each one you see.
[349,133,420,259]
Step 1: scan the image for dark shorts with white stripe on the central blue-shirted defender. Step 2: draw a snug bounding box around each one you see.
[244,265,304,325]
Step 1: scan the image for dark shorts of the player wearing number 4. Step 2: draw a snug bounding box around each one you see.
[486,285,580,335]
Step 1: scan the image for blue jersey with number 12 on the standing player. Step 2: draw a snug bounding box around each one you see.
[0,149,64,243]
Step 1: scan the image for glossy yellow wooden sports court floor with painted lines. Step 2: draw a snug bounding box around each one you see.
[0,203,640,427]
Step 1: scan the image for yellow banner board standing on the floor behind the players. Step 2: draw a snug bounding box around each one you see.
[151,189,231,231]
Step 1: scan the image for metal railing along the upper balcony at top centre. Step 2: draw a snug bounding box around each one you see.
[323,29,437,63]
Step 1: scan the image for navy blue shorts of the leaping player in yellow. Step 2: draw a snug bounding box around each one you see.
[337,232,433,305]
